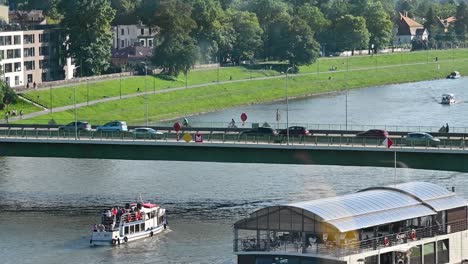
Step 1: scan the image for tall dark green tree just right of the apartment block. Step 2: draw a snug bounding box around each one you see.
[60,0,115,76]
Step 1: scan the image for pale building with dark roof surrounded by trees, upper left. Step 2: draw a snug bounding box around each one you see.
[112,25,157,50]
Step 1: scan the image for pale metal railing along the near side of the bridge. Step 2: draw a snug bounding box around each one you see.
[0,128,466,150]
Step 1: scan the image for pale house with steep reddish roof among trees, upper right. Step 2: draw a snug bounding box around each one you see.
[393,13,429,46]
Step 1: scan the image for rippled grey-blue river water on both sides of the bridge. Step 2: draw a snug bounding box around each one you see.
[0,79,468,264]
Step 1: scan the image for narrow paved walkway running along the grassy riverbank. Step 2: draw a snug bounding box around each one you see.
[3,60,454,123]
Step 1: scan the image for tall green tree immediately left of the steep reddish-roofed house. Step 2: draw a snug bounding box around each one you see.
[364,2,393,53]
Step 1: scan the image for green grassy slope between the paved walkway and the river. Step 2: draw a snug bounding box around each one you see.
[16,50,468,124]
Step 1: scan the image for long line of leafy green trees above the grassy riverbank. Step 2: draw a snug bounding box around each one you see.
[5,0,468,76]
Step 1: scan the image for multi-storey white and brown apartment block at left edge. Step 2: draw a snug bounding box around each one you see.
[0,28,72,87]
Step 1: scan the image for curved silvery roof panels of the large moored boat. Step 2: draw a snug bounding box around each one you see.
[236,182,468,232]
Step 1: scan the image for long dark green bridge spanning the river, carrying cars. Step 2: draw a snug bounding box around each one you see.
[0,128,468,172]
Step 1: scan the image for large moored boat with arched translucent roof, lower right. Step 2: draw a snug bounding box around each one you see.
[234,182,468,264]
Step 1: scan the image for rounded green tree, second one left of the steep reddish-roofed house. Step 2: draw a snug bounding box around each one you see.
[335,15,369,54]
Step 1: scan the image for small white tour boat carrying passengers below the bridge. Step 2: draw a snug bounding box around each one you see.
[90,203,167,246]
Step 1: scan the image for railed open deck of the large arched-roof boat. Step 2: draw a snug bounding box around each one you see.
[234,220,468,257]
